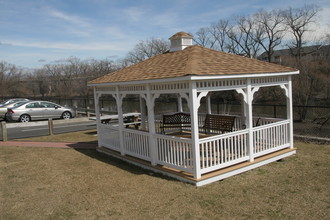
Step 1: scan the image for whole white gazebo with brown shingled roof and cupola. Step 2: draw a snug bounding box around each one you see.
[89,32,299,186]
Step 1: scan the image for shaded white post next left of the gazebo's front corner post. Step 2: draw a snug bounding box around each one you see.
[146,84,159,166]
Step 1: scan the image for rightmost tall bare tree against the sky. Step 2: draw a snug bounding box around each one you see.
[284,5,320,58]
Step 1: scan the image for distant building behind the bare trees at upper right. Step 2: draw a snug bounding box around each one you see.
[258,45,330,64]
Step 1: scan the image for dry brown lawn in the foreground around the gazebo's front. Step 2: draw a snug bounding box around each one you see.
[0,143,330,219]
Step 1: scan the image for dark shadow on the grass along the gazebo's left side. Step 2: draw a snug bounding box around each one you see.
[70,141,179,182]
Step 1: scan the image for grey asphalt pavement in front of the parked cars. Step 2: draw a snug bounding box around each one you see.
[0,121,96,140]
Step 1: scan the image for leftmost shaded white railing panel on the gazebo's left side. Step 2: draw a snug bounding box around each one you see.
[99,124,120,151]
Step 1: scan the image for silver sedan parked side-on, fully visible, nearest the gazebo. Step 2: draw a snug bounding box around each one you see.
[7,101,75,122]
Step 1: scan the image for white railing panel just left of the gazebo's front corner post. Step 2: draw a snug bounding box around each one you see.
[154,135,194,173]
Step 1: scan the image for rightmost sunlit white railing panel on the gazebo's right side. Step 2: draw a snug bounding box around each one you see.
[253,120,290,157]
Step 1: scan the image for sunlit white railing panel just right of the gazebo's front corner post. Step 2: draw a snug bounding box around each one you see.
[199,130,249,174]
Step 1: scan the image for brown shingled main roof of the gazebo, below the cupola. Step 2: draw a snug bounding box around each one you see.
[89,45,297,84]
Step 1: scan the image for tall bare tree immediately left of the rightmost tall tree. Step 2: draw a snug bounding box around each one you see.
[254,9,286,62]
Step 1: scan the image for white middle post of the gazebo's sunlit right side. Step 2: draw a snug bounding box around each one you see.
[246,79,254,162]
